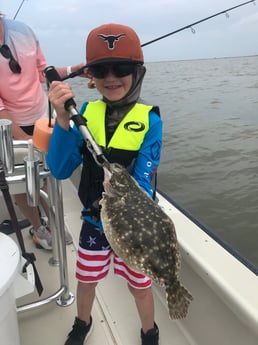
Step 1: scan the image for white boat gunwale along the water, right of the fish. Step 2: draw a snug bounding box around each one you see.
[157,190,258,335]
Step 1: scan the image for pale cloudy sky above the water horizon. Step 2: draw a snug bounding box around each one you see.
[0,0,258,66]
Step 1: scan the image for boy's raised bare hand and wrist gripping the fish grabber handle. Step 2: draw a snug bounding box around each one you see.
[48,81,74,130]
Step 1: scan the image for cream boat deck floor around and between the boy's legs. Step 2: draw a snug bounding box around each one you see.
[15,180,189,345]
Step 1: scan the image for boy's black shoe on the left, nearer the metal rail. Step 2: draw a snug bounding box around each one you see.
[64,317,92,345]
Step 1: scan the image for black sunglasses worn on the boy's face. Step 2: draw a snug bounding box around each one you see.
[89,62,137,79]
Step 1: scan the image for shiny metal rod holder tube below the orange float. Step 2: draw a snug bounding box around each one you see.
[24,139,40,206]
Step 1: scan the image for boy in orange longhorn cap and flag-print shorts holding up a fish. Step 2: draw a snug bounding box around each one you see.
[47,24,162,345]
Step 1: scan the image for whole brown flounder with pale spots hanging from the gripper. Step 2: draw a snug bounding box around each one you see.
[100,163,192,319]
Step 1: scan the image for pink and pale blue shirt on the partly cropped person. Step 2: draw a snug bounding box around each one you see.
[0,18,47,126]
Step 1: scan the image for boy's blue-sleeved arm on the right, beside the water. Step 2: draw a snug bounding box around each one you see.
[132,112,162,196]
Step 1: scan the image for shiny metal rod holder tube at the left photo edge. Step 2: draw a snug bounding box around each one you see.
[0,119,14,175]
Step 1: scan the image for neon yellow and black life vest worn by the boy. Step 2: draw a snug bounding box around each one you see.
[78,101,153,208]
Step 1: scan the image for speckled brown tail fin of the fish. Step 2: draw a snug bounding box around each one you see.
[166,281,193,320]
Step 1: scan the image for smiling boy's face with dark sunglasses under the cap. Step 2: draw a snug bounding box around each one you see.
[89,64,135,101]
